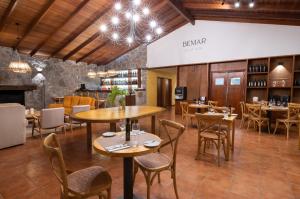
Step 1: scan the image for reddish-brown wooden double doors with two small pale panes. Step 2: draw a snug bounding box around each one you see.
[210,71,246,115]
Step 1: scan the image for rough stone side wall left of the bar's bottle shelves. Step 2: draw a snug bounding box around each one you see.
[0,47,99,109]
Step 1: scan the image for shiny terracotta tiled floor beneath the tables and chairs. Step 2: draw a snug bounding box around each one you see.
[0,109,300,199]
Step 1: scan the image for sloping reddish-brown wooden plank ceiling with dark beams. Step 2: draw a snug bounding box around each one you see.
[0,0,300,65]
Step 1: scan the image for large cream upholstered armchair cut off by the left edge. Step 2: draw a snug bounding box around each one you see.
[0,103,27,149]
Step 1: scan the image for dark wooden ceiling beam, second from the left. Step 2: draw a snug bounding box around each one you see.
[14,0,55,49]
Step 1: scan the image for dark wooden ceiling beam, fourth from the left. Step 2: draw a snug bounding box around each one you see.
[51,2,111,57]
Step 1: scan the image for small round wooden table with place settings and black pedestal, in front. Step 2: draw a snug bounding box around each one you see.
[93,132,161,199]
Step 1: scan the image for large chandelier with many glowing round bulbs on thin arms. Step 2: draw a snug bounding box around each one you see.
[99,0,163,46]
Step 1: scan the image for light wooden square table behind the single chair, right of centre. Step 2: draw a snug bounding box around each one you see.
[200,112,238,161]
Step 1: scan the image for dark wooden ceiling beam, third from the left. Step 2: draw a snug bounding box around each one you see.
[30,0,90,56]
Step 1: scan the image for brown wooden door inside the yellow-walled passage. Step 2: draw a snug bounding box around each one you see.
[157,77,172,108]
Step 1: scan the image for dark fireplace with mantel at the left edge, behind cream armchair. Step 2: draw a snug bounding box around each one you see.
[0,85,36,105]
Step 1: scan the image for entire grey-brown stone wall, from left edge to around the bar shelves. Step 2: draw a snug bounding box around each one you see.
[0,45,147,109]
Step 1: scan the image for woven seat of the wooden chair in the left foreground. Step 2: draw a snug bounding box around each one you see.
[67,166,112,195]
